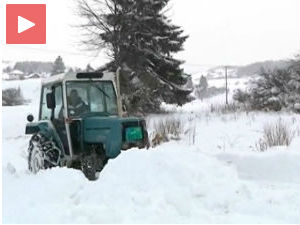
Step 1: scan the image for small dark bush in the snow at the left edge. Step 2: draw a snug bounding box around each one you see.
[2,87,26,106]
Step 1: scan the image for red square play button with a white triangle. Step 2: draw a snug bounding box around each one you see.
[6,4,46,44]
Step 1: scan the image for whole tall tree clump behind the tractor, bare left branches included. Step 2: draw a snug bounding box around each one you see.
[79,0,192,113]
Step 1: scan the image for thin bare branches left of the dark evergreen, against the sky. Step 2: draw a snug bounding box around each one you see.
[78,0,127,68]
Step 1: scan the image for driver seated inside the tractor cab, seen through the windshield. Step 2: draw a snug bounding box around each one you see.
[68,89,89,116]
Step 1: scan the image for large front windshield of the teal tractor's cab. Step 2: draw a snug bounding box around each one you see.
[66,81,118,117]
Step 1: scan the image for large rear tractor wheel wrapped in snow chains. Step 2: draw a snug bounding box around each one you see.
[28,133,61,174]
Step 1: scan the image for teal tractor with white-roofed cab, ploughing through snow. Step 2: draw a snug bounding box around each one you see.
[25,71,149,180]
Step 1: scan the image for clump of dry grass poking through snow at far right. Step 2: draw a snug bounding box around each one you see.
[256,119,294,151]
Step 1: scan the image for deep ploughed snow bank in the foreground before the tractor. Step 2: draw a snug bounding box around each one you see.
[3,142,300,223]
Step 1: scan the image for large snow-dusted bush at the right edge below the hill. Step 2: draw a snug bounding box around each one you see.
[234,55,300,113]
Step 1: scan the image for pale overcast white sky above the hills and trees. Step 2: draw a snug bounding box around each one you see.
[1,0,300,67]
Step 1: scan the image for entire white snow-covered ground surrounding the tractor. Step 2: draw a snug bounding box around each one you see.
[2,78,300,224]
